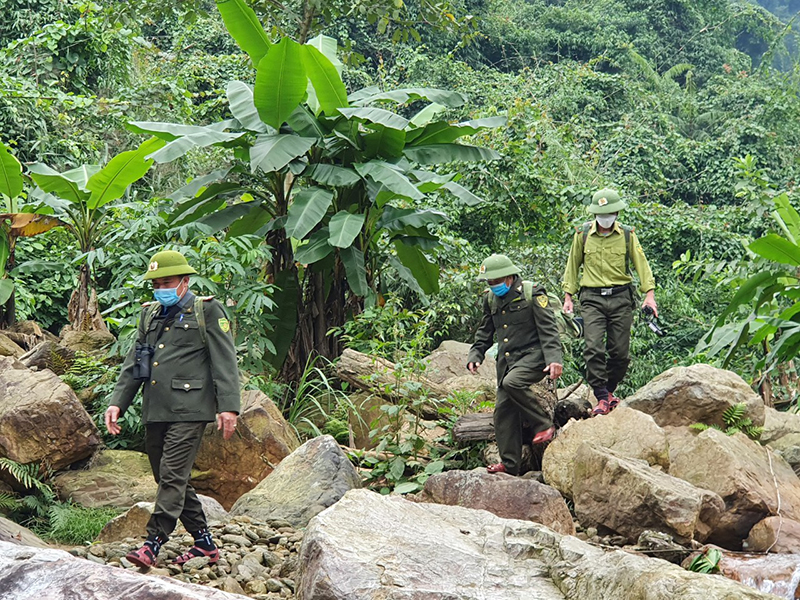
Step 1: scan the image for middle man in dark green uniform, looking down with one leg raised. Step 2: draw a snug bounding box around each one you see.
[467,254,562,475]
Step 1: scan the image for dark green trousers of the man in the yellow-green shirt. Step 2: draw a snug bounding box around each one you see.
[580,287,633,391]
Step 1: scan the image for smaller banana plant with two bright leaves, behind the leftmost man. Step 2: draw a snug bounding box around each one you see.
[28,138,165,331]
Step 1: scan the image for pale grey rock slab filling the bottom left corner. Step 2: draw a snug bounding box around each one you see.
[0,542,247,600]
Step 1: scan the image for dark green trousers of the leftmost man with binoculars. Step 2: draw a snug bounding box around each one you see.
[145,421,208,539]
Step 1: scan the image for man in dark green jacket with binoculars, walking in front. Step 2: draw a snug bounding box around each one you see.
[105,251,240,567]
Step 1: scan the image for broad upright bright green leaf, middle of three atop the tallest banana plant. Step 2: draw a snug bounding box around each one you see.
[253,38,308,129]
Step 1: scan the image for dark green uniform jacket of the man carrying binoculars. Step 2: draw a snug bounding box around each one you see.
[110,294,241,423]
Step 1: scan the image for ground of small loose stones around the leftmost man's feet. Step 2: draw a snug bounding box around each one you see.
[70,516,303,600]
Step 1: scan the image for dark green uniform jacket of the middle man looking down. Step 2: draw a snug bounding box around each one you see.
[467,277,562,383]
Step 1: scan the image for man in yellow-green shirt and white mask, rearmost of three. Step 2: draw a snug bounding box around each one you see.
[563,189,658,415]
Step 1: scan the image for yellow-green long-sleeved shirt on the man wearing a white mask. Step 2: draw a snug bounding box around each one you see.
[562,221,656,294]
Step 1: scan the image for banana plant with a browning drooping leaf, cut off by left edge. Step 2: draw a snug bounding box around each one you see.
[0,142,63,326]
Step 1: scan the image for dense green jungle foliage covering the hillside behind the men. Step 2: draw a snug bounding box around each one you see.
[0,0,800,540]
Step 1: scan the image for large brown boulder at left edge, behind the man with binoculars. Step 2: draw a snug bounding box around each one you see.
[0,356,101,470]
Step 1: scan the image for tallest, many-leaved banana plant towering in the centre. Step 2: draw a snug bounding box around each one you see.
[130,0,505,374]
